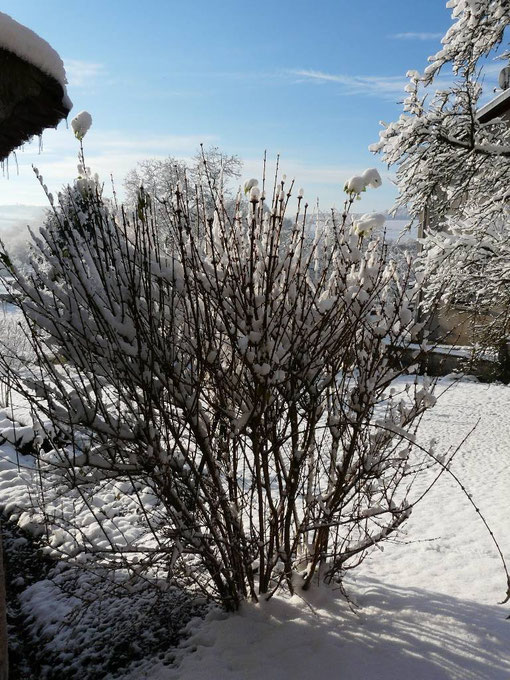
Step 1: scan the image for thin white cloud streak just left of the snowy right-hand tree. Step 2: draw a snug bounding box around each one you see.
[290,69,408,99]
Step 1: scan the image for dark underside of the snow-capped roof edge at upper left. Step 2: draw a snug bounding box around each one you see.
[0,48,69,161]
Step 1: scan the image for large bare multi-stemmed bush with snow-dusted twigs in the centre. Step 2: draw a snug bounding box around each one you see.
[0,158,440,609]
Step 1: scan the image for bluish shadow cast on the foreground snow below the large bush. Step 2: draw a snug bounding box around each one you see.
[130,578,510,680]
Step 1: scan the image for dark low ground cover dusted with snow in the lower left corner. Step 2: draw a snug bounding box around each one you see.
[2,523,205,680]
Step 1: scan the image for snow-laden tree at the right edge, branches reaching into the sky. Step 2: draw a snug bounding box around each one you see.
[371,0,510,370]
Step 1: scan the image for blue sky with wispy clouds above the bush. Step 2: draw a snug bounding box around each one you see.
[0,0,466,218]
